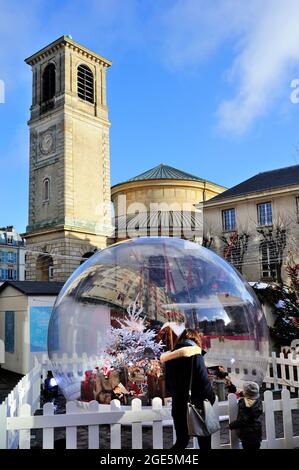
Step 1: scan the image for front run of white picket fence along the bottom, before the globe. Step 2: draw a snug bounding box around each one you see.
[2,390,299,449]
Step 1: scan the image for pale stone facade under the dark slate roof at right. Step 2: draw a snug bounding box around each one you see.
[203,185,299,284]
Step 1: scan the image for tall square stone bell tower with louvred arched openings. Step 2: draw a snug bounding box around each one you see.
[25,36,112,281]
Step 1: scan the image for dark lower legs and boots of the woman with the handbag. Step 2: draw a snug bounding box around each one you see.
[171,402,211,451]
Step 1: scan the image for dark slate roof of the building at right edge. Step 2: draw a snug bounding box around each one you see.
[208,165,299,202]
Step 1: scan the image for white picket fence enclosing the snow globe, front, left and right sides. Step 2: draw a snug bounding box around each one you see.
[0,353,299,449]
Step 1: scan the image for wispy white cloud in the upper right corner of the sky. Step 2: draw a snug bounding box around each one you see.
[218,0,299,133]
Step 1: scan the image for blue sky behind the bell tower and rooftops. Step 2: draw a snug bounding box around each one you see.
[0,0,299,231]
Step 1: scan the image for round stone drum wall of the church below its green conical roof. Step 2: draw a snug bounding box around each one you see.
[110,169,225,243]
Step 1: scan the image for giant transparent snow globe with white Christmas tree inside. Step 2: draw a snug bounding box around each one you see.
[48,237,269,405]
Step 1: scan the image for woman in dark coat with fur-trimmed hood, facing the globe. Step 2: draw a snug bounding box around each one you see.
[160,329,215,451]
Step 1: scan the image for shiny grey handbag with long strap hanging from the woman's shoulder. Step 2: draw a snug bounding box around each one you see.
[187,356,220,436]
